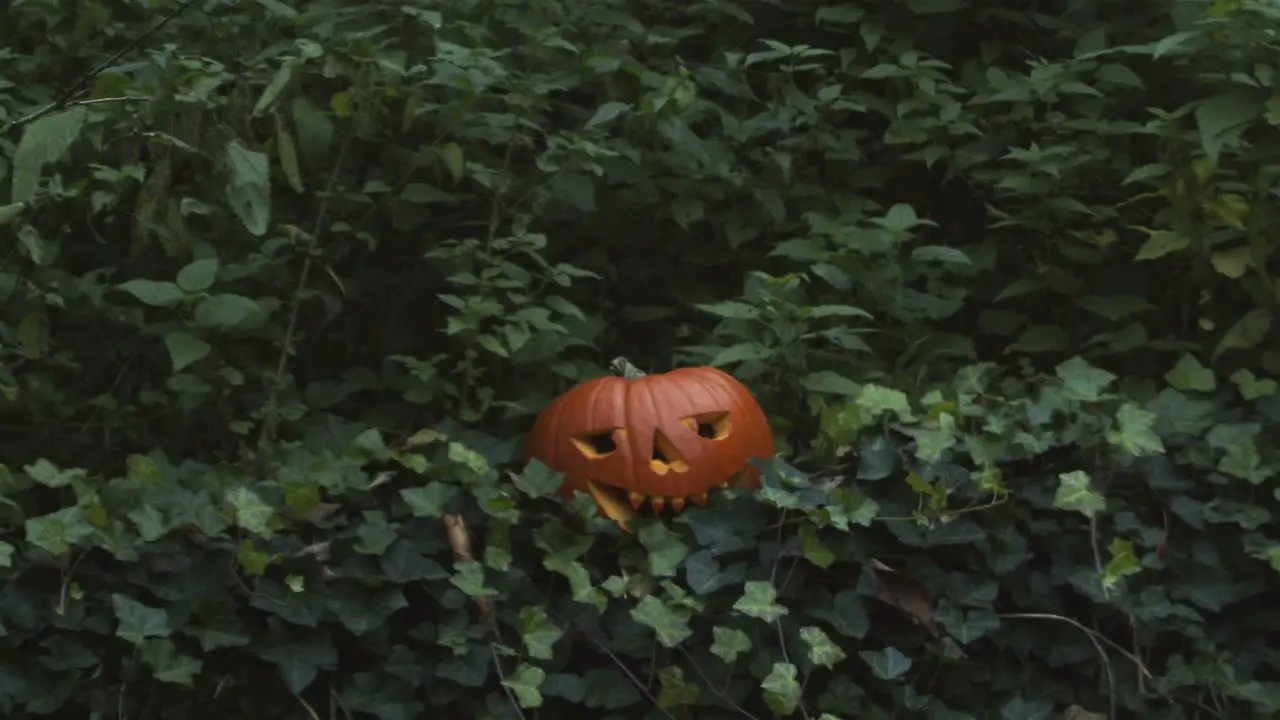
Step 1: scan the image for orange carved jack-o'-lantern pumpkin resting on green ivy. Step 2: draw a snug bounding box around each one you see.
[525,368,773,529]
